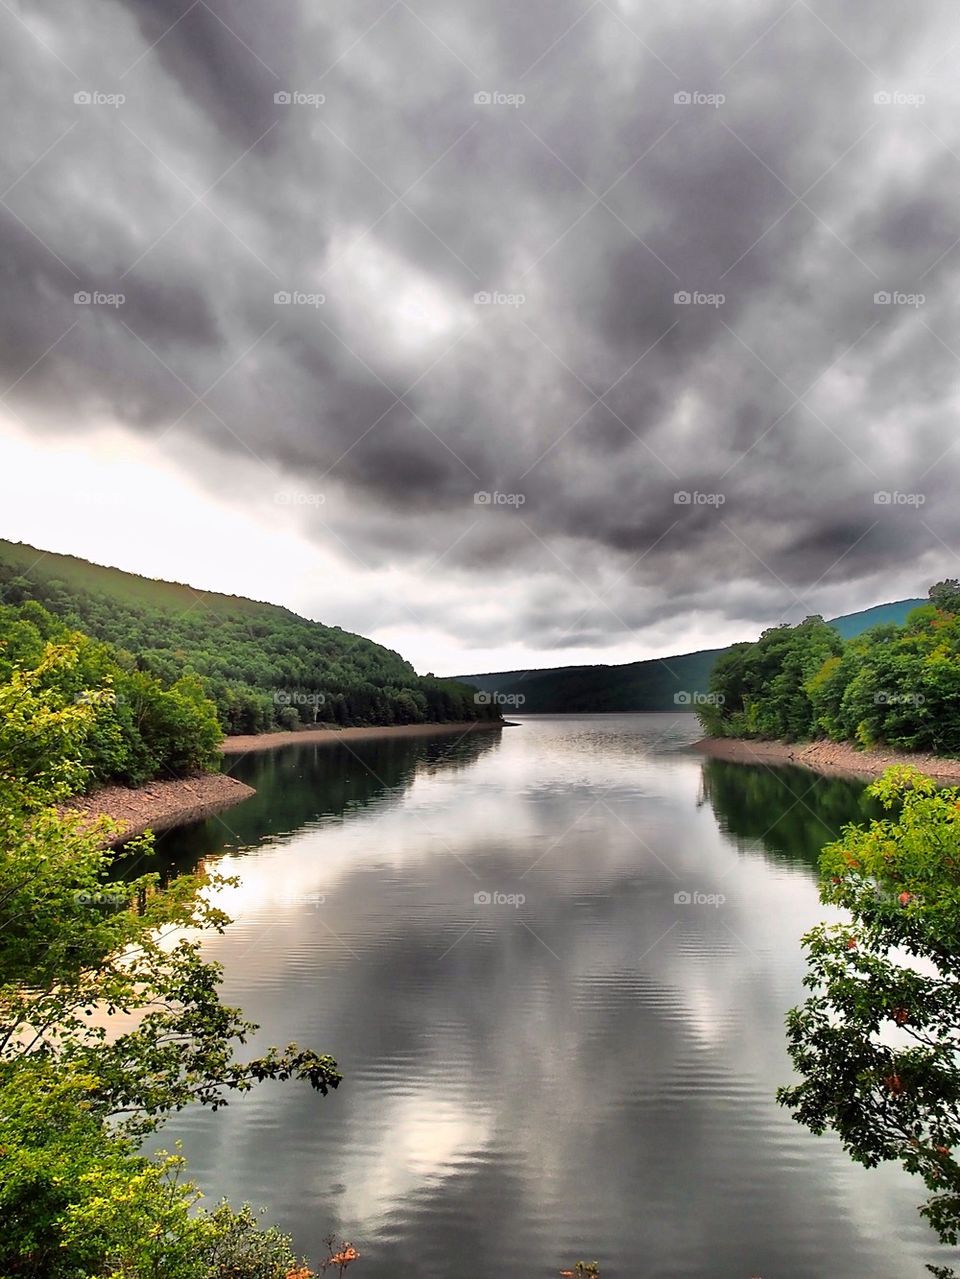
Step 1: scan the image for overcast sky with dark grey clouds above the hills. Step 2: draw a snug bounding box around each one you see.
[0,0,960,674]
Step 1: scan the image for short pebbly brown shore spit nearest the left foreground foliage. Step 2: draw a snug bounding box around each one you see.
[60,773,257,848]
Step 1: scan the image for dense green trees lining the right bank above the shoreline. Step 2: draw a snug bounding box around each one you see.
[699,581,960,755]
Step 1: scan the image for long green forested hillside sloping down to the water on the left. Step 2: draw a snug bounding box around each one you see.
[0,541,499,733]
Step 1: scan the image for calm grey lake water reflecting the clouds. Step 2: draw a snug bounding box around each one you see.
[154,715,951,1279]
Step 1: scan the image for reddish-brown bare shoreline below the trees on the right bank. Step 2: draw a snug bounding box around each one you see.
[692,737,960,781]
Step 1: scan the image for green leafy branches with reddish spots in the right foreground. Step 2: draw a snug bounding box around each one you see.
[778,767,960,1243]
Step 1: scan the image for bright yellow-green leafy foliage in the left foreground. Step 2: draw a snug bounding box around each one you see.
[0,632,340,1279]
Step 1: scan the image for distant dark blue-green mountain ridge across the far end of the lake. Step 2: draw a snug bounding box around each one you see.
[454,599,928,715]
